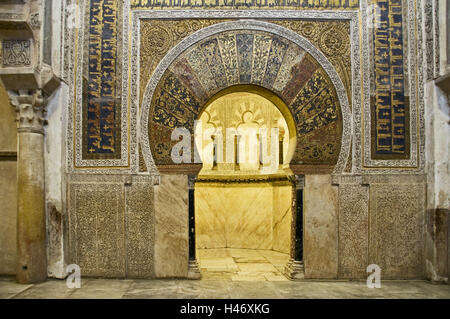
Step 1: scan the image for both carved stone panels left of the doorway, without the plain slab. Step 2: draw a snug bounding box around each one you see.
[68,174,155,278]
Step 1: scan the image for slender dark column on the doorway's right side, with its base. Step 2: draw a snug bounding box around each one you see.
[285,175,305,280]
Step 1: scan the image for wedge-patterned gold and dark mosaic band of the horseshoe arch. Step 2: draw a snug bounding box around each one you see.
[142,26,342,165]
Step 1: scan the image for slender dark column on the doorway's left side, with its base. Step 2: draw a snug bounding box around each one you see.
[188,175,201,279]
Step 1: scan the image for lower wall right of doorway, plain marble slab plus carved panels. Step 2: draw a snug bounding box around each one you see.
[304,175,426,279]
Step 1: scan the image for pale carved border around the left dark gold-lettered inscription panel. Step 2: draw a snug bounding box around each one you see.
[63,0,137,174]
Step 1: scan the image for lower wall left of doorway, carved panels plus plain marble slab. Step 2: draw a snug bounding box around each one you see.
[67,174,192,278]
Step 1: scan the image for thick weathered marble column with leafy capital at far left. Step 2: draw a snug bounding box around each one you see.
[8,90,47,284]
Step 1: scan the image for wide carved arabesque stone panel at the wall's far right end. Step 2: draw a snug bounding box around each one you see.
[369,183,425,279]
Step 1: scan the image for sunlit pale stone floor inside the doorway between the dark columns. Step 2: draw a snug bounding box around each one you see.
[197,248,289,281]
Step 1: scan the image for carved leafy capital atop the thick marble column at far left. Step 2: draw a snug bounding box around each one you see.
[8,89,47,134]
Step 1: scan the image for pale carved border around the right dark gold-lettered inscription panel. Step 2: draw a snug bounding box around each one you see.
[360,0,425,174]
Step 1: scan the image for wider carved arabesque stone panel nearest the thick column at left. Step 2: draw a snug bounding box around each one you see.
[69,182,125,277]
